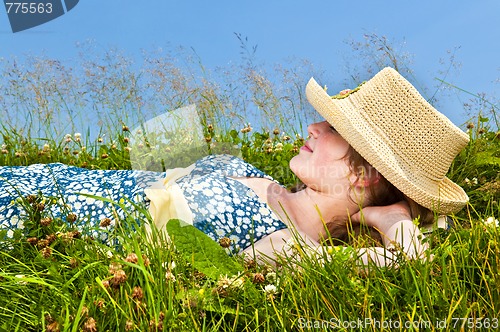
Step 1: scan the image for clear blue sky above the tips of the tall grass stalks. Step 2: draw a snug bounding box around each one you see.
[0,0,500,124]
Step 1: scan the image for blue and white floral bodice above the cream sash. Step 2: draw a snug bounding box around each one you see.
[177,155,286,252]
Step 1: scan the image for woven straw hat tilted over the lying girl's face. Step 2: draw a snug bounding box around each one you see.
[306,68,469,214]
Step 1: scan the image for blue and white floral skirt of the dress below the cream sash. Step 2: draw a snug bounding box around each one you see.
[0,163,162,242]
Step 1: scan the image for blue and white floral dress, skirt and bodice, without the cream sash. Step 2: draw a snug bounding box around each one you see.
[0,155,286,252]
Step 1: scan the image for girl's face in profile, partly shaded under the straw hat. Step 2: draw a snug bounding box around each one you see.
[290,121,355,195]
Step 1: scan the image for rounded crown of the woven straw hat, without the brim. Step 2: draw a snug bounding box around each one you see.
[339,68,469,180]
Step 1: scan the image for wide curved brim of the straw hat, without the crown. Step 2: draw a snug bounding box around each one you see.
[306,78,469,214]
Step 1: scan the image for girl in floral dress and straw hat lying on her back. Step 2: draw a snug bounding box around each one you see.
[0,68,469,265]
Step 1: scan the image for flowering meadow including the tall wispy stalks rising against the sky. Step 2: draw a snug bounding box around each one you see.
[0,42,500,331]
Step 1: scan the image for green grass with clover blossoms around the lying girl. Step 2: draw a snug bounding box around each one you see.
[0,48,500,331]
